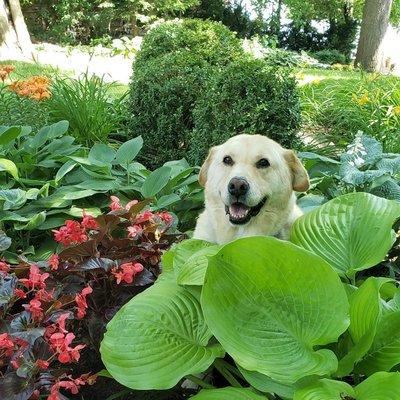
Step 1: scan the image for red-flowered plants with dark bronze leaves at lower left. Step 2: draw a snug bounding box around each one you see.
[0,197,181,400]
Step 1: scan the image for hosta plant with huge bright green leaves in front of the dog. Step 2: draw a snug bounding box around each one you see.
[101,193,400,400]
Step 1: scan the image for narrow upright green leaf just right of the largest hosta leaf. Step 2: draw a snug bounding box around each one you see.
[336,277,391,376]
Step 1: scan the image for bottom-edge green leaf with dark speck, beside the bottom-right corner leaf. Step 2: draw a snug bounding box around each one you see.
[293,379,354,400]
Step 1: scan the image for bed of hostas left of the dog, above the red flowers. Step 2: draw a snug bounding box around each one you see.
[0,121,202,253]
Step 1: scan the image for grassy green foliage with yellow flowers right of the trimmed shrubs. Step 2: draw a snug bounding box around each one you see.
[297,69,400,152]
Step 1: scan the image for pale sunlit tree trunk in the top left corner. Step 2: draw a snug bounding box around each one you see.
[0,0,34,59]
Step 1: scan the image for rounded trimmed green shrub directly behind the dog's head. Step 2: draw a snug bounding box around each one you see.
[189,59,300,164]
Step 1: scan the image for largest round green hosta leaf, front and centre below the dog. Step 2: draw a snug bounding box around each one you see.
[202,237,349,383]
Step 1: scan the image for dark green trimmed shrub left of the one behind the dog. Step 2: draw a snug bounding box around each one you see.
[129,52,209,167]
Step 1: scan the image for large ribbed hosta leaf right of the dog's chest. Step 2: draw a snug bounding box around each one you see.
[291,193,400,276]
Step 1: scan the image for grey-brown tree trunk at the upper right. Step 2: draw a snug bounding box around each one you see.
[355,0,393,72]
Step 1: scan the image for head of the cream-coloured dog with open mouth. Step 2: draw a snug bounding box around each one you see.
[199,135,310,225]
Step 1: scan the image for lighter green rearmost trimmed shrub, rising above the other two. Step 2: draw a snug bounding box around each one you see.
[136,19,244,65]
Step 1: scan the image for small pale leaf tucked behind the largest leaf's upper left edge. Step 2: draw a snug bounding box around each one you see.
[176,243,221,285]
